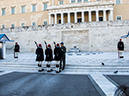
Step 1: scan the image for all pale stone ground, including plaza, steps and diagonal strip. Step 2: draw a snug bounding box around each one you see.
[0,52,129,96]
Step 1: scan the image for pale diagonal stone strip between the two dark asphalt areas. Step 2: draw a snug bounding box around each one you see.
[90,74,116,96]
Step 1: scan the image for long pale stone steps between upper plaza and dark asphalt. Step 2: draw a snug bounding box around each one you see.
[0,64,129,72]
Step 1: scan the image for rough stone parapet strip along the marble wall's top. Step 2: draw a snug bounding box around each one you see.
[0,20,129,33]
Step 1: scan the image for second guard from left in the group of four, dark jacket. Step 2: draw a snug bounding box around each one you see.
[45,44,53,72]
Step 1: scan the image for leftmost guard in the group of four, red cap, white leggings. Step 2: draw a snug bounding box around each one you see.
[36,44,44,72]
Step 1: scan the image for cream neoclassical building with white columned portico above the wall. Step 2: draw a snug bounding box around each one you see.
[0,0,129,28]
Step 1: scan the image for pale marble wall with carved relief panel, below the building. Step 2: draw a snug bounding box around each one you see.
[0,20,129,52]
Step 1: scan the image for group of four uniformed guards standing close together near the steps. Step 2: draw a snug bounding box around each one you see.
[36,42,66,73]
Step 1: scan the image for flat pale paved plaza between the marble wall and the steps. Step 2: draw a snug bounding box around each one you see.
[0,52,129,66]
